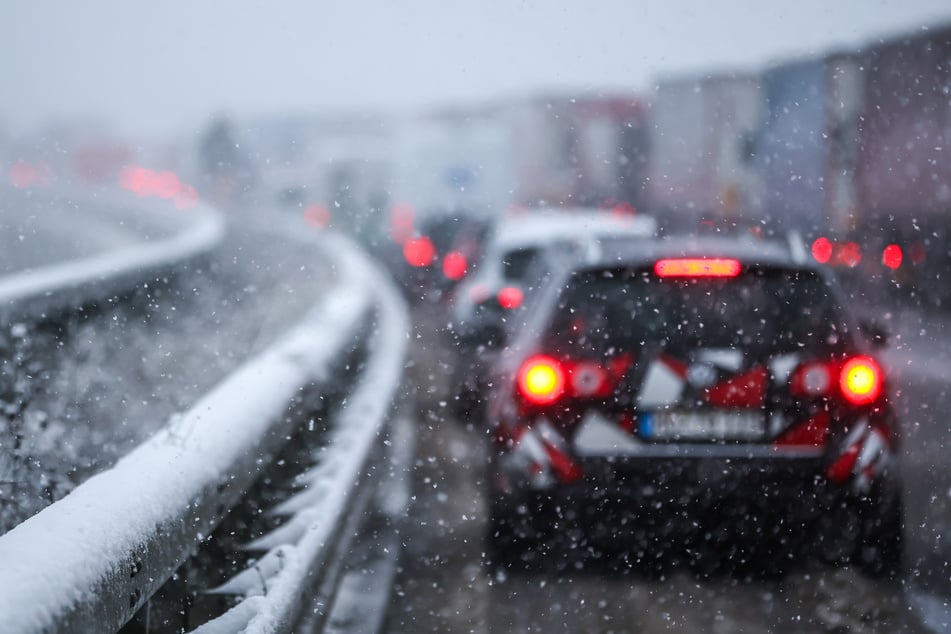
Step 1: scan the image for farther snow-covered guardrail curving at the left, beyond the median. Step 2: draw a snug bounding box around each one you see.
[0,191,225,320]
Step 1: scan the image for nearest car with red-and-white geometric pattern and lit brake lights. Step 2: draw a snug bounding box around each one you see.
[487,237,902,575]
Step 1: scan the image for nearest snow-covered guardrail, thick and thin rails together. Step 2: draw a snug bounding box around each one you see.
[0,233,407,632]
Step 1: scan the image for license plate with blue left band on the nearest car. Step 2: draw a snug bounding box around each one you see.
[638,410,766,441]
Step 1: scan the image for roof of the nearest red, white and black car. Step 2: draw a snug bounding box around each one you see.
[579,235,819,270]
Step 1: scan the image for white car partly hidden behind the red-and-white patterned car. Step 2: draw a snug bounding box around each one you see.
[449,207,656,422]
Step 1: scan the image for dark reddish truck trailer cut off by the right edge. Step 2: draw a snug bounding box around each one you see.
[857,21,951,296]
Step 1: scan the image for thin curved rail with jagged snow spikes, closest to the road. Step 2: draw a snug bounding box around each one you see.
[193,232,409,634]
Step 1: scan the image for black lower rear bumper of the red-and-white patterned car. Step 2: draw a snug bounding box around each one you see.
[490,457,900,537]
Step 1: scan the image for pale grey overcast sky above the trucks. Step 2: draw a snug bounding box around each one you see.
[0,0,951,132]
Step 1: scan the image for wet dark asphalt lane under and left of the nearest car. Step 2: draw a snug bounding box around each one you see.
[385,302,933,634]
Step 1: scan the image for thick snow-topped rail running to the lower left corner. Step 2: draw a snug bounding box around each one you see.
[0,233,378,633]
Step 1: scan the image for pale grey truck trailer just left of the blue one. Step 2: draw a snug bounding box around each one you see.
[648,73,761,229]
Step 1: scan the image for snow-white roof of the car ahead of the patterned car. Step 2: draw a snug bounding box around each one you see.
[493,208,657,250]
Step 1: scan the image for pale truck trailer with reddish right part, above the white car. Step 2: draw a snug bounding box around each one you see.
[500,94,649,210]
